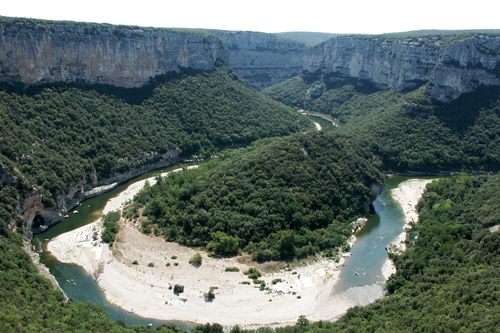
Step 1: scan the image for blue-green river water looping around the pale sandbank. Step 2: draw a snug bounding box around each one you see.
[33,166,418,329]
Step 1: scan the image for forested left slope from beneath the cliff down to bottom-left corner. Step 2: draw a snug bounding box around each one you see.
[0,65,312,332]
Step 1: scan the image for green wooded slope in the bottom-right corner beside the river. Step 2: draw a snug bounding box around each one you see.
[304,176,500,332]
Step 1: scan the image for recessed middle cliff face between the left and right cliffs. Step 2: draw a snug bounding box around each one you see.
[213,31,306,90]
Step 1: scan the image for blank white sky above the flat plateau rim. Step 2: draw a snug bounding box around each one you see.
[0,0,500,34]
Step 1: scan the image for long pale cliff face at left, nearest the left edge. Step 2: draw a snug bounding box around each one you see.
[0,24,228,88]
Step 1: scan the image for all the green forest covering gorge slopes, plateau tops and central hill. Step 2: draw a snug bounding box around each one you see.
[0,22,500,332]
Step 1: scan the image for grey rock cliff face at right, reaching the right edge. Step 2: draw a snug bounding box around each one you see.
[303,36,500,101]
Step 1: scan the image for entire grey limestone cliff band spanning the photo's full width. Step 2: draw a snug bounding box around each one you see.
[0,21,500,101]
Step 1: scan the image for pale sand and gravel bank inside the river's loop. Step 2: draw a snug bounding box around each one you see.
[48,175,434,327]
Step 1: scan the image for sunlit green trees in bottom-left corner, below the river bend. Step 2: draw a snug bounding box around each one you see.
[0,230,178,332]
